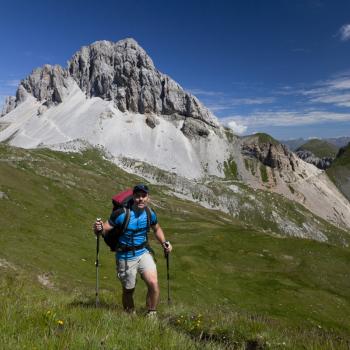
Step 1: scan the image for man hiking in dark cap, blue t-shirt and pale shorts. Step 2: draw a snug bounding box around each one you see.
[93,184,172,316]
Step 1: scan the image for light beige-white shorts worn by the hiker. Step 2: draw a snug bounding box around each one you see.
[117,252,157,289]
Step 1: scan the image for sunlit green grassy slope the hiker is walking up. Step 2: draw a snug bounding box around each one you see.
[0,145,350,349]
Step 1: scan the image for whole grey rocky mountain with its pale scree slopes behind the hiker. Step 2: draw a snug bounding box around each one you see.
[0,39,350,236]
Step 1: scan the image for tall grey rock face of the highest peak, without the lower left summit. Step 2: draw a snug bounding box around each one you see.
[68,39,218,127]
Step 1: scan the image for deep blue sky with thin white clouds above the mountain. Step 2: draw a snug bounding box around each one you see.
[0,0,350,139]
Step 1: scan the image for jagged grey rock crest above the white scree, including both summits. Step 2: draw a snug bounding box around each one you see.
[2,38,219,134]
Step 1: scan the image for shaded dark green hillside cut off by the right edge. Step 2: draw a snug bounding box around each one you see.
[327,143,350,200]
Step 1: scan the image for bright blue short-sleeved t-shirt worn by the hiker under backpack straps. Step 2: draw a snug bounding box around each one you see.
[108,209,158,260]
